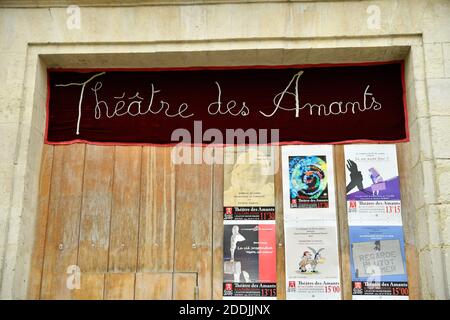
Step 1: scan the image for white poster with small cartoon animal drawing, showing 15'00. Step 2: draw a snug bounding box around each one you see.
[284,220,341,300]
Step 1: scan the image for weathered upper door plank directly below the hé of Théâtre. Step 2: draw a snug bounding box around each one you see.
[78,145,114,273]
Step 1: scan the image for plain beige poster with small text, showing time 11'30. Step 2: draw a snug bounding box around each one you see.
[223,146,276,220]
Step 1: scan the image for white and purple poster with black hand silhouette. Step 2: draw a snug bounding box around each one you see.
[344,144,402,225]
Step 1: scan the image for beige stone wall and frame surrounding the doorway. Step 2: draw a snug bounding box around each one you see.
[0,0,450,299]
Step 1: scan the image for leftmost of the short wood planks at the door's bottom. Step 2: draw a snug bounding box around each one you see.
[105,272,136,300]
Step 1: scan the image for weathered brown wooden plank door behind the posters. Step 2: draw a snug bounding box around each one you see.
[28,144,418,299]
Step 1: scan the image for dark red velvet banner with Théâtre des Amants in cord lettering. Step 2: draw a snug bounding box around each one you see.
[46,62,408,145]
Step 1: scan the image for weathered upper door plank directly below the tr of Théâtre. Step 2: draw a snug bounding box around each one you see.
[138,147,175,272]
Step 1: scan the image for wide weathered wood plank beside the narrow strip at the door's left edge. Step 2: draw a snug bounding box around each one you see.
[41,144,85,299]
